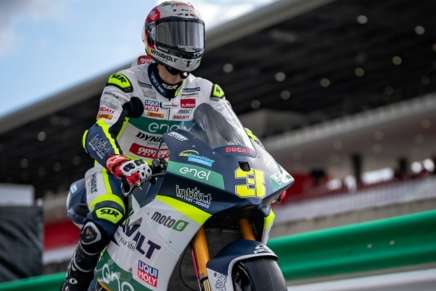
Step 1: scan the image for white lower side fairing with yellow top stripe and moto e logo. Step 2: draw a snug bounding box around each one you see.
[96,195,210,291]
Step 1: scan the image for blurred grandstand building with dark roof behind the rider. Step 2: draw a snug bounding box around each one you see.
[0,0,436,272]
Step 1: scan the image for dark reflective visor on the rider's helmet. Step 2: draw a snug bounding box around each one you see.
[156,18,205,53]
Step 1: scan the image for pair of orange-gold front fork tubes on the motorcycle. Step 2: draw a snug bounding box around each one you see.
[192,218,255,291]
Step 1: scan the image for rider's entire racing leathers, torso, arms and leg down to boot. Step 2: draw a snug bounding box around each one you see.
[64,58,227,290]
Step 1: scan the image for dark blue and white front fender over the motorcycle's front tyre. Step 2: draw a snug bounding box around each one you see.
[207,239,277,291]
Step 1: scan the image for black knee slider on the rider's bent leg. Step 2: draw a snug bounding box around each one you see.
[80,221,110,255]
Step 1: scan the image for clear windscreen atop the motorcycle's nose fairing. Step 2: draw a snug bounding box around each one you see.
[185,101,254,151]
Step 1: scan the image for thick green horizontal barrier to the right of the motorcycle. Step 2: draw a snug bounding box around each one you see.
[268,210,436,281]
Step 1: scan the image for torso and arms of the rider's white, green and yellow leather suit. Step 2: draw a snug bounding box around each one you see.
[84,59,224,169]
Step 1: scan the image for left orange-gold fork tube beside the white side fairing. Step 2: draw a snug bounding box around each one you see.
[192,227,211,291]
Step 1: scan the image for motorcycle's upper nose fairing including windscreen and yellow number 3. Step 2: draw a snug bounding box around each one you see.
[161,102,294,219]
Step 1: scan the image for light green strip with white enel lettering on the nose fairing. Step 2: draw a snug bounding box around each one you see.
[167,161,224,189]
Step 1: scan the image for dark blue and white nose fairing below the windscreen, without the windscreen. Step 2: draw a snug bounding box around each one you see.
[163,129,294,215]
